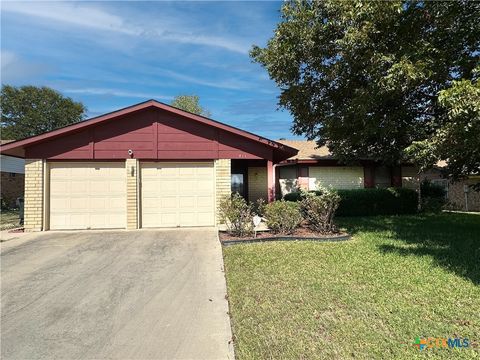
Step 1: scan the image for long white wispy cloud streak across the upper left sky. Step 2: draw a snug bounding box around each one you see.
[2,1,250,54]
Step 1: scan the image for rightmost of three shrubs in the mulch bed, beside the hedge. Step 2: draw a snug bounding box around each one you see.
[301,190,340,233]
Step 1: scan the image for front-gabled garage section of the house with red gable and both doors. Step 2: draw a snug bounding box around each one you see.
[0,100,297,231]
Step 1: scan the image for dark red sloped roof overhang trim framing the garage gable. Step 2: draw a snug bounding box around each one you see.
[0,100,298,162]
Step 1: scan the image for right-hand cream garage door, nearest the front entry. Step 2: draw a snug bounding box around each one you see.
[141,162,215,228]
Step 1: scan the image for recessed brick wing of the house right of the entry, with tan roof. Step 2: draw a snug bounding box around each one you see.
[276,140,414,196]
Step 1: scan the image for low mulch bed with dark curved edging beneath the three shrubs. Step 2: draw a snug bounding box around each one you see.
[219,227,351,246]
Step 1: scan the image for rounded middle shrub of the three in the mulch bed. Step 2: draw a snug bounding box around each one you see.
[265,200,303,234]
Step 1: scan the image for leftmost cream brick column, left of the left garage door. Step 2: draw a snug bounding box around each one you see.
[24,159,44,231]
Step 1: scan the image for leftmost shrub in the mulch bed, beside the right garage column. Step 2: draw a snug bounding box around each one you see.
[219,193,253,237]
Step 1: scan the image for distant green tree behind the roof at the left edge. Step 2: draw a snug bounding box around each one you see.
[1,85,86,140]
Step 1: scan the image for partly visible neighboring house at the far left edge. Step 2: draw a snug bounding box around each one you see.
[0,140,25,207]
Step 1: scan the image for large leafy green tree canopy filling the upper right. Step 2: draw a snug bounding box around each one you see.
[251,0,480,172]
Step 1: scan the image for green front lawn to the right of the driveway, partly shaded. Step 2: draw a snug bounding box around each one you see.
[224,213,480,359]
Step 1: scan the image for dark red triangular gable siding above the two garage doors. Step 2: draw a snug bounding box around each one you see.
[25,108,273,160]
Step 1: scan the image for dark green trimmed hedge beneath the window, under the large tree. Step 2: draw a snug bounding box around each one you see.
[337,188,418,216]
